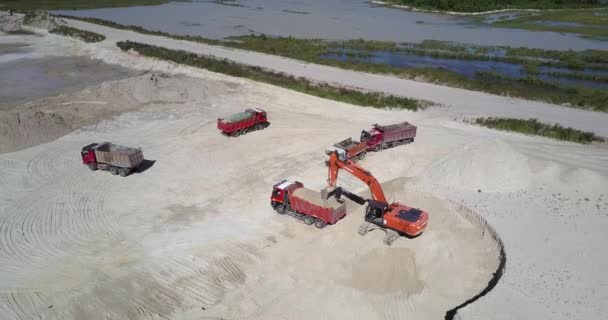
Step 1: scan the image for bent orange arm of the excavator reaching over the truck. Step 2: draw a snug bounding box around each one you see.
[321,149,387,203]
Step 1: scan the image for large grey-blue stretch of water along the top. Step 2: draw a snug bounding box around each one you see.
[56,0,608,50]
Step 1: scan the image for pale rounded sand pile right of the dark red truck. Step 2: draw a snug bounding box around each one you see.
[421,139,532,192]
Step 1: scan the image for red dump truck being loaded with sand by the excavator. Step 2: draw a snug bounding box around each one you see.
[270,180,346,229]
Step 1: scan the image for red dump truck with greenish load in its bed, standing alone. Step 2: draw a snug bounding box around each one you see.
[217,108,270,137]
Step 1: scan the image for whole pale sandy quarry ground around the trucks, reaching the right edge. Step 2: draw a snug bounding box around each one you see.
[0,19,608,319]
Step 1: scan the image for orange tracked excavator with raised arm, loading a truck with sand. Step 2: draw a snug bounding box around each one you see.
[321,148,429,245]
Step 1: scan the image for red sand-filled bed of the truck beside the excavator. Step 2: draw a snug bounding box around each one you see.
[289,187,346,224]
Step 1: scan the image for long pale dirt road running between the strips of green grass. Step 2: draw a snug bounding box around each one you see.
[67,19,608,137]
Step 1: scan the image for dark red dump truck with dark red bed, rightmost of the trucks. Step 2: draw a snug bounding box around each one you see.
[361,122,416,151]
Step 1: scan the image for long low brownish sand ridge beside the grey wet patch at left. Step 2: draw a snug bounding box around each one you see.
[0,74,224,153]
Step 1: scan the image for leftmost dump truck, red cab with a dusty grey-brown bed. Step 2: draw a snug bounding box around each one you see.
[80,142,144,177]
